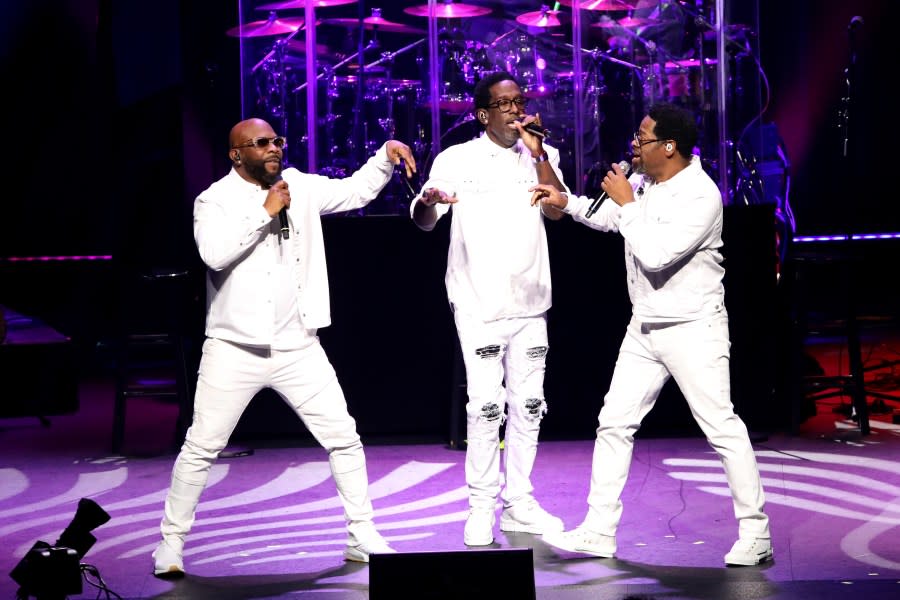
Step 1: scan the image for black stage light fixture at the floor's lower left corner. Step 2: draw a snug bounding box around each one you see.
[9,498,110,600]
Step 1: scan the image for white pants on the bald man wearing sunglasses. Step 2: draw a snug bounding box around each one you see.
[160,338,373,543]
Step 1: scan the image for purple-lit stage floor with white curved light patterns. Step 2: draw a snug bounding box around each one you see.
[0,372,900,600]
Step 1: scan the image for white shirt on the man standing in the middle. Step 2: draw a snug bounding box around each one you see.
[410,135,562,321]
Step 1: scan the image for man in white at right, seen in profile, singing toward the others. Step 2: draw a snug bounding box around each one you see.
[532,103,772,566]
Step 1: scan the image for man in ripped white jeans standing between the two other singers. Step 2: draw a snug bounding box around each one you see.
[410,72,566,546]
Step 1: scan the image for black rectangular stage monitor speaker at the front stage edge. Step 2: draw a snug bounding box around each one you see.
[369,548,535,600]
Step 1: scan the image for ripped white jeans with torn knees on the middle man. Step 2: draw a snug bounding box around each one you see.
[454,311,548,510]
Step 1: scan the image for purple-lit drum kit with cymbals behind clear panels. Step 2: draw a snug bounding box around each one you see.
[226,0,749,204]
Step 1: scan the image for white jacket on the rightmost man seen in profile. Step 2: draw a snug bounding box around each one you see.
[565,156,725,323]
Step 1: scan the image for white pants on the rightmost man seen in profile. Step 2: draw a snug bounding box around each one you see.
[584,311,769,538]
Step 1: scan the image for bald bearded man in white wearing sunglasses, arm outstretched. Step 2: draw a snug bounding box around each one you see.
[153,119,416,577]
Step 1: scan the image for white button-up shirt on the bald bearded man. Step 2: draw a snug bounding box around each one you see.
[194,146,393,349]
